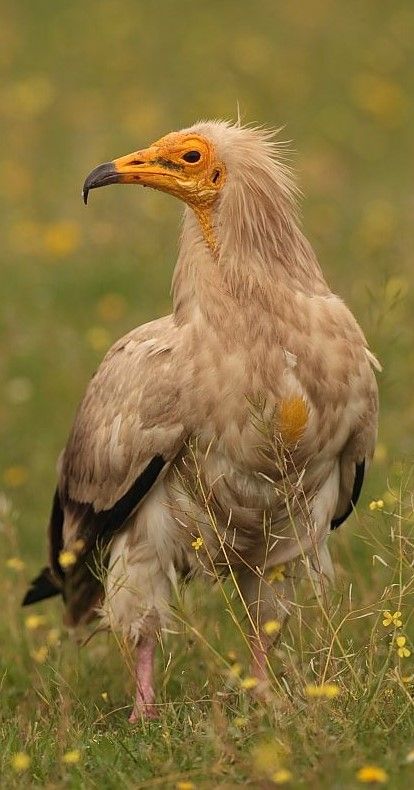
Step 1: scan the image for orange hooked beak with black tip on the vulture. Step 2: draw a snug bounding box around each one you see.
[82,145,184,205]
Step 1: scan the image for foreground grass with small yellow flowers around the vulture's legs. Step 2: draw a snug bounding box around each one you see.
[0,486,414,788]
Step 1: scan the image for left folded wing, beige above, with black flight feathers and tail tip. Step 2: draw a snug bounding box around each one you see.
[24,316,186,622]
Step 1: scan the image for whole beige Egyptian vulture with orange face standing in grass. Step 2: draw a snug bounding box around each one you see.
[24,121,379,721]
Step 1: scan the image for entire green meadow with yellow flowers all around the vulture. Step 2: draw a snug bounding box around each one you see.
[0,0,414,790]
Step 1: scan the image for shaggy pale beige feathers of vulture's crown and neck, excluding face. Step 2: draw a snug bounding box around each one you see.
[172,122,330,323]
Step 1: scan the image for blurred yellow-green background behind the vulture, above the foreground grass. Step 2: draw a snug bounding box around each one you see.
[0,0,414,566]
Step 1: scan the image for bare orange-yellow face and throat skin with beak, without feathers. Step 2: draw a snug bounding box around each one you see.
[83,132,226,255]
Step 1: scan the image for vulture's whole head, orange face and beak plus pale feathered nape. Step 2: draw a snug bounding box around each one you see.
[83,121,297,257]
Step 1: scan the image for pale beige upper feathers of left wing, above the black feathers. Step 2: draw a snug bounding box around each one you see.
[59,316,185,512]
